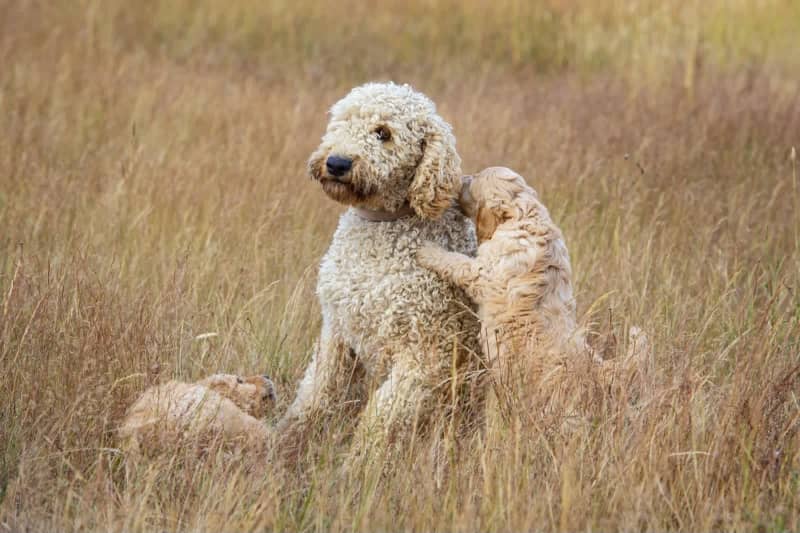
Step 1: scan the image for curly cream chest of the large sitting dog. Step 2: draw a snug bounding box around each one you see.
[317,212,474,359]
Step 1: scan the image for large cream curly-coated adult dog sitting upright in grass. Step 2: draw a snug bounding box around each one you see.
[278,83,481,460]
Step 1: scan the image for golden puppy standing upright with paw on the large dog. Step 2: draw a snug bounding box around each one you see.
[417,167,645,400]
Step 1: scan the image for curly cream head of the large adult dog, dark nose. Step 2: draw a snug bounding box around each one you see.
[308,83,461,218]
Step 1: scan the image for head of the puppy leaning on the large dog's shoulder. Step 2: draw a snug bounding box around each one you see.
[458,167,536,242]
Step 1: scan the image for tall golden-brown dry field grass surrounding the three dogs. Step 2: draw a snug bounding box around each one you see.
[0,0,800,531]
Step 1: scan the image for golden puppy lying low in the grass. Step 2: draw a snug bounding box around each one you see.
[119,374,275,455]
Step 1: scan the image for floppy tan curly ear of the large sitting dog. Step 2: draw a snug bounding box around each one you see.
[408,116,461,219]
